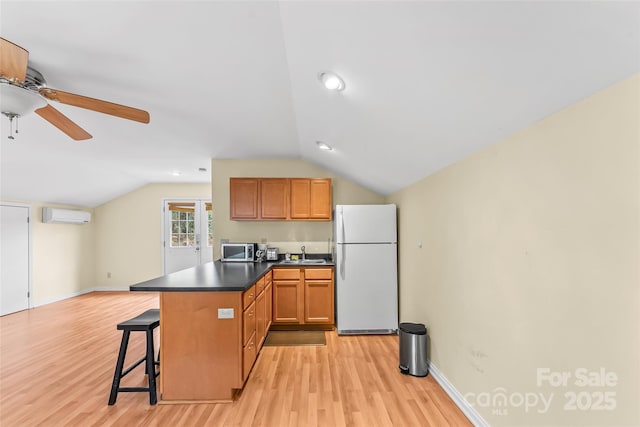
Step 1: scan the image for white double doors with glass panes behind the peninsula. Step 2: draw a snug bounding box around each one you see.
[164,199,213,274]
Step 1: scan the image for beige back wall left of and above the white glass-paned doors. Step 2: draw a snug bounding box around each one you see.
[95,183,211,288]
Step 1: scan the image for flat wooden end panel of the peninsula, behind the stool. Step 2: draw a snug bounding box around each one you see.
[160,292,243,401]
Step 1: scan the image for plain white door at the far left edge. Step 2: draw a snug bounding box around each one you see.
[0,205,30,315]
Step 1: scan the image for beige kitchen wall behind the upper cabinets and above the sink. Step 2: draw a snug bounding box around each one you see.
[211,159,384,259]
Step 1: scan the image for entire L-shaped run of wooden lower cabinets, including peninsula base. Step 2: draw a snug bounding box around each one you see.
[159,267,334,402]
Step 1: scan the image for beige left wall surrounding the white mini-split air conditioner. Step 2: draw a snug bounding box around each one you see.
[3,200,96,307]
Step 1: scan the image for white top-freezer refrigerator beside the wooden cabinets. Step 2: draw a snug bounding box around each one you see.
[334,204,398,335]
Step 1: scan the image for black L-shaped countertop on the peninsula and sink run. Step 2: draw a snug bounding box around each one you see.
[129,261,334,292]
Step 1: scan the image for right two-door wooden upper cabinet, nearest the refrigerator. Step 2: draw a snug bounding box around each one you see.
[291,178,332,220]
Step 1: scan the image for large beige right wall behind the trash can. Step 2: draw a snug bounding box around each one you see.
[388,76,640,425]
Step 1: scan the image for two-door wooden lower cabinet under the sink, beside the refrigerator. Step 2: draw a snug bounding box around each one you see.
[273,267,335,327]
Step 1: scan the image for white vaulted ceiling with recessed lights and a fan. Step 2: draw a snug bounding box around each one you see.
[0,0,640,206]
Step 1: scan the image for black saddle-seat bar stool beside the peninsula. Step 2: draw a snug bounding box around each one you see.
[109,308,160,405]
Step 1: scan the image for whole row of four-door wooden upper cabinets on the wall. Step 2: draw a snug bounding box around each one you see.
[229,178,332,221]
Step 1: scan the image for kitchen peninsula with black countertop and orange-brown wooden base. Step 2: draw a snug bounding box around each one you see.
[130,261,333,403]
